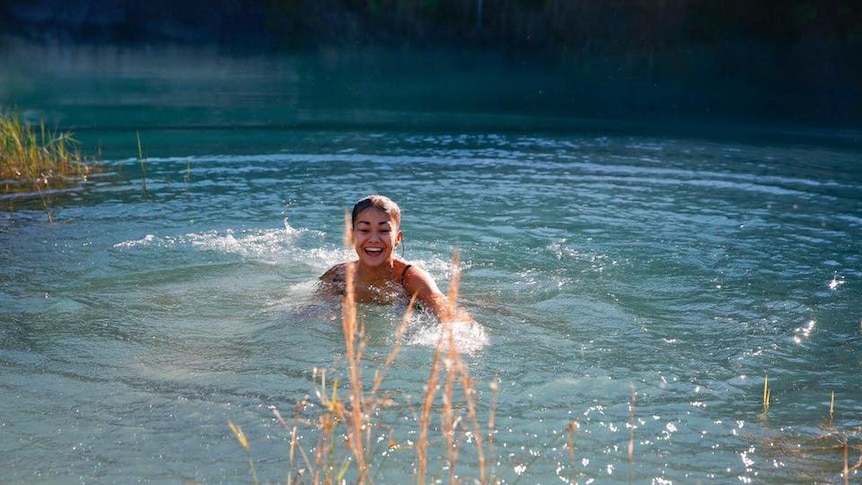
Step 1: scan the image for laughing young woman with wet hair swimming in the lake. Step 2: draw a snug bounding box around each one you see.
[320,195,472,321]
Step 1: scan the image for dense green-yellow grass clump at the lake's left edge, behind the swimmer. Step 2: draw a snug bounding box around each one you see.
[0,113,92,222]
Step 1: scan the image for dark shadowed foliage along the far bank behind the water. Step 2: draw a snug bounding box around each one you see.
[0,0,862,51]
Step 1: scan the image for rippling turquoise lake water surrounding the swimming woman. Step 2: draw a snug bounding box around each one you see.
[0,43,862,484]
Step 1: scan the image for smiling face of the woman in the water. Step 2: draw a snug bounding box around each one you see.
[353,207,401,267]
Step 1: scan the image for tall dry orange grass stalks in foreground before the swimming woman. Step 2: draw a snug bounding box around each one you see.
[229,215,497,485]
